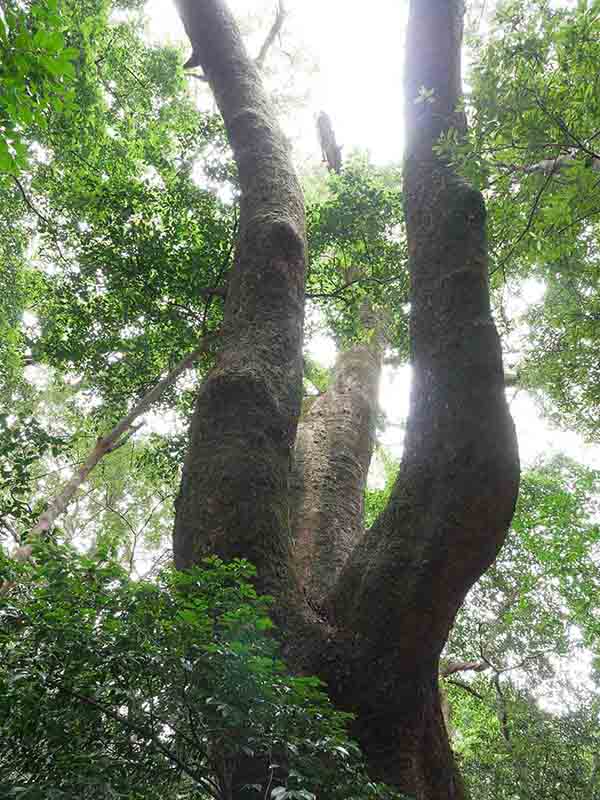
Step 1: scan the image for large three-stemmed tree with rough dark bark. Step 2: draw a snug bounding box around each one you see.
[174,0,519,800]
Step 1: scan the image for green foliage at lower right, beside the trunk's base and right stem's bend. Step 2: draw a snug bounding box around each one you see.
[444,457,600,800]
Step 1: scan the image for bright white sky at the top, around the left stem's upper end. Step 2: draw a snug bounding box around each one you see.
[146,0,406,163]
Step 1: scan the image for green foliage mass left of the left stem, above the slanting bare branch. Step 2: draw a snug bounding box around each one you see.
[0,0,236,413]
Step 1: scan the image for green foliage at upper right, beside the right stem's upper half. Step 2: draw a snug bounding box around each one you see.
[442,0,600,439]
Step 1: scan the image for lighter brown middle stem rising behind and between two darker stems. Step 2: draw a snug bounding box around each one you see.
[292,345,381,612]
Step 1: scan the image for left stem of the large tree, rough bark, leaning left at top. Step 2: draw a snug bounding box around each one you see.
[174,0,305,591]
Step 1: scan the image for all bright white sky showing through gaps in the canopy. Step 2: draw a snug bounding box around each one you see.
[146,0,600,468]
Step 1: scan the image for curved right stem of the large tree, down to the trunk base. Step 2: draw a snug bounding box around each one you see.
[324,0,519,800]
